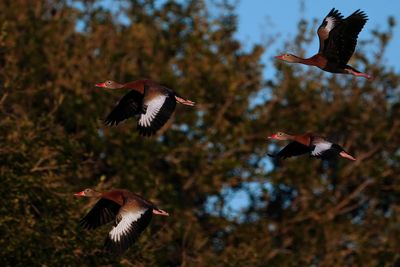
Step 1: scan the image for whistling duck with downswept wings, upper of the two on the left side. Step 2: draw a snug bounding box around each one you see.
[96,79,194,136]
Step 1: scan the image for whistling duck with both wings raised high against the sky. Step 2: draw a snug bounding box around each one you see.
[276,8,372,79]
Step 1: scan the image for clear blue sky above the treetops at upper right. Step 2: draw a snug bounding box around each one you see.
[236,0,400,78]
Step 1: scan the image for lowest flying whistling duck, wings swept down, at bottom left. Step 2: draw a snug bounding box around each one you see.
[75,188,169,254]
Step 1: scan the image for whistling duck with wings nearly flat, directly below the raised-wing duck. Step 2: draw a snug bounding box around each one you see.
[268,132,356,160]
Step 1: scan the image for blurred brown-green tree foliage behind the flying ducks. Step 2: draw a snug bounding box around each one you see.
[0,0,400,266]
